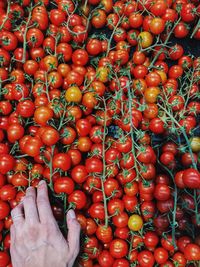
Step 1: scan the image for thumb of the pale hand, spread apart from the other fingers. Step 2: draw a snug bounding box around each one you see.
[67,209,81,267]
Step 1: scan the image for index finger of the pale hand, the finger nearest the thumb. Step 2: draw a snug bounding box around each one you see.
[37,181,55,224]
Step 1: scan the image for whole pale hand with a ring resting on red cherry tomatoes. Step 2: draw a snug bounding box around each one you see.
[10,181,80,267]
